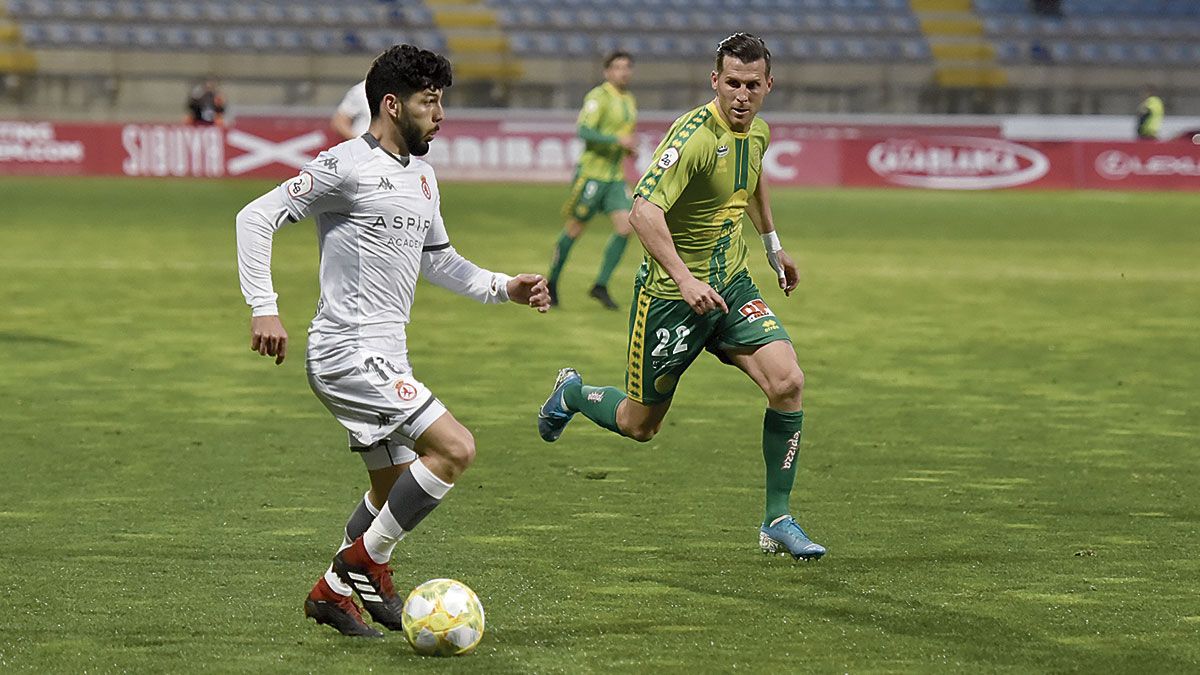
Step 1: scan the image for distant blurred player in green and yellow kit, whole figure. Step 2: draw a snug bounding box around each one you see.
[546,52,637,310]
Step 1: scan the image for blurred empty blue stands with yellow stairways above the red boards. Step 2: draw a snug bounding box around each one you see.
[0,0,1200,120]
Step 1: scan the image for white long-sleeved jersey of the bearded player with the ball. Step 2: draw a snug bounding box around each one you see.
[238,133,511,359]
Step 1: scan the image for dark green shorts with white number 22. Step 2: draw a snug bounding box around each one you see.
[625,271,792,405]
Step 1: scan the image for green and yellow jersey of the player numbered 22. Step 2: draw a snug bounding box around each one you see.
[635,102,770,299]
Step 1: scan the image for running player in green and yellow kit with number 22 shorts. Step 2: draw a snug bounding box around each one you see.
[538,32,826,560]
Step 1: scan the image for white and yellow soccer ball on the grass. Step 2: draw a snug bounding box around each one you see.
[403,579,484,656]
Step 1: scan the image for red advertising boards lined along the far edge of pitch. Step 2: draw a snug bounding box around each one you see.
[0,113,1200,190]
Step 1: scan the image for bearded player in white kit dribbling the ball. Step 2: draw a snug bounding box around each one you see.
[238,44,550,638]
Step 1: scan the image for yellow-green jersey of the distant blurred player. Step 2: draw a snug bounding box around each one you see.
[576,82,637,181]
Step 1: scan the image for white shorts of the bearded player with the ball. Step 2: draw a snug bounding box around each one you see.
[307,351,446,470]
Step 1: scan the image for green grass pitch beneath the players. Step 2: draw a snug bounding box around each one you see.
[0,178,1200,673]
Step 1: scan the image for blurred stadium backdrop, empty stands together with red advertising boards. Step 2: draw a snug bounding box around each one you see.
[0,0,1200,190]
